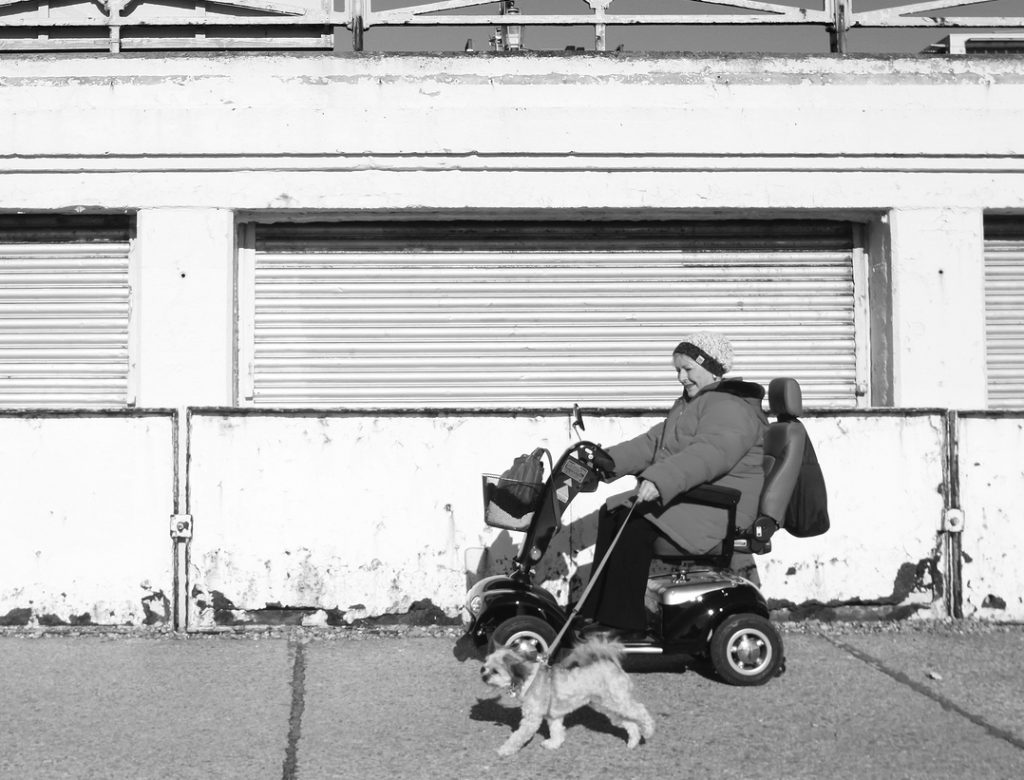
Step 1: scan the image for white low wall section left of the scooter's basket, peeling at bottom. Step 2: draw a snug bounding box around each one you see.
[189,415,568,624]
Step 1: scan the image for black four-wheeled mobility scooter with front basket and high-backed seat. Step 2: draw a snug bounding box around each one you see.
[466,378,807,686]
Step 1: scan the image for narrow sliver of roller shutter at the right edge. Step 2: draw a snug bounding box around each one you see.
[985,217,1024,408]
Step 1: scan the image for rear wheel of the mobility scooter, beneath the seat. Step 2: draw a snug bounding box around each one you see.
[711,613,782,685]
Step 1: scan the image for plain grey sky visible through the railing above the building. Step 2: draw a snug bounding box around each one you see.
[337,0,1024,54]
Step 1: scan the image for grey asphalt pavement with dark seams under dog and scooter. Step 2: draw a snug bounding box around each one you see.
[0,624,1024,780]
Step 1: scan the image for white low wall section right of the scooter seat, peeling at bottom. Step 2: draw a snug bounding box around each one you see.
[758,415,945,617]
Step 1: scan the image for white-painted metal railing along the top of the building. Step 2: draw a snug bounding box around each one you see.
[0,0,1024,53]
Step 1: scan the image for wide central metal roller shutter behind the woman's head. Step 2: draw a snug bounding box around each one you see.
[242,221,858,408]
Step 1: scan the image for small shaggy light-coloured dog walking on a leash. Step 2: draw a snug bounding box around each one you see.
[480,636,654,755]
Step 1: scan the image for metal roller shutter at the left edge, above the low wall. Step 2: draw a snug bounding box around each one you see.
[0,217,129,407]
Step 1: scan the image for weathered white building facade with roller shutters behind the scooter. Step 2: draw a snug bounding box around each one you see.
[0,53,1024,627]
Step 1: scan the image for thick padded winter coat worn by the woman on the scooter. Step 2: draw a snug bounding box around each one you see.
[607,379,768,554]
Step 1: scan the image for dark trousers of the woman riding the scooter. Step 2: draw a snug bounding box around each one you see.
[580,508,659,631]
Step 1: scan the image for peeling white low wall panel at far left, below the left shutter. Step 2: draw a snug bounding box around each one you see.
[0,416,174,625]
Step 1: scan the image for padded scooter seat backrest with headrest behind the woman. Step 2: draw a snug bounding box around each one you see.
[758,378,807,526]
